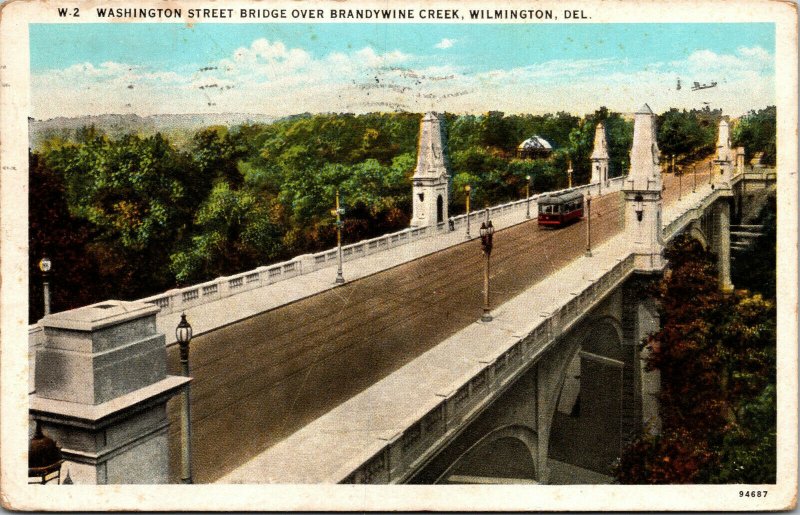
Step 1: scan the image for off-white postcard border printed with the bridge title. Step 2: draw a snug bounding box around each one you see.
[0,0,798,511]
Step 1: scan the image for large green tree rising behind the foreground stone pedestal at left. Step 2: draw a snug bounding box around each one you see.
[45,130,203,298]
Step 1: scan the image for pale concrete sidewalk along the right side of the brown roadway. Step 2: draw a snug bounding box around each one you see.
[219,172,713,483]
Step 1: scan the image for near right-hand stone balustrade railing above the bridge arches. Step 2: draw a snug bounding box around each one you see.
[340,255,634,484]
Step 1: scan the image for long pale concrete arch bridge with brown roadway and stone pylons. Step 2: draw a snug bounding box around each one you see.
[30,106,774,484]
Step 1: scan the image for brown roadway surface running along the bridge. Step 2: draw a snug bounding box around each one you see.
[169,161,708,483]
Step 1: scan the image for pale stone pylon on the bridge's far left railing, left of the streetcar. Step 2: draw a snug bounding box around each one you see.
[411,113,450,227]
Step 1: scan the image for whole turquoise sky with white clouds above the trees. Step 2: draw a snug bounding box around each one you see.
[30,23,775,119]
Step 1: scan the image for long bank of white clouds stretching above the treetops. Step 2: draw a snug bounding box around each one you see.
[31,38,775,118]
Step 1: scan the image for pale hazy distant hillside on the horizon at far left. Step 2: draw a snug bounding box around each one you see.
[29,113,276,149]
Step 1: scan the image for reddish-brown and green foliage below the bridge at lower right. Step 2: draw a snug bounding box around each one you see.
[616,238,776,484]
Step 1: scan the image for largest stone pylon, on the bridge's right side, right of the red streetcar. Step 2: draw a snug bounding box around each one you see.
[624,104,665,272]
